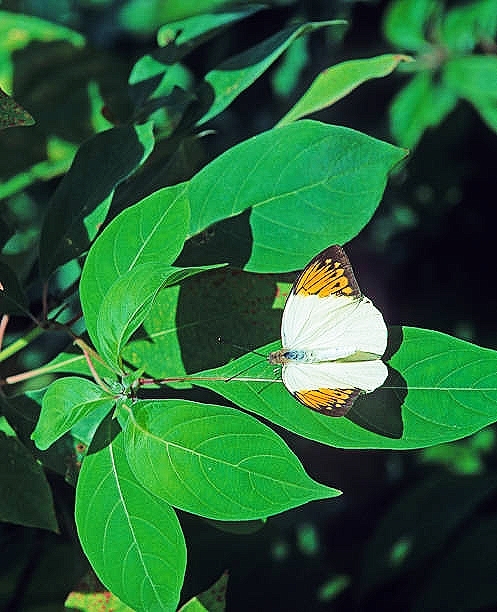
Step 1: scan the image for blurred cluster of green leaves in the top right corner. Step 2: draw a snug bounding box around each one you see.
[384,0,497,147]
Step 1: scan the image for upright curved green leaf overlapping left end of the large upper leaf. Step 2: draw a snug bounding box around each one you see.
[80,184,189,344]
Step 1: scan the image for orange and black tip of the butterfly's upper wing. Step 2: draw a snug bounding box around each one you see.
[292,245,361,298]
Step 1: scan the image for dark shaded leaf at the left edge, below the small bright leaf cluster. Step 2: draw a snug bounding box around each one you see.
[0,430,58,531]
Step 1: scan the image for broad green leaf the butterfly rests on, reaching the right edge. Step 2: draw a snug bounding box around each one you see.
[190,327,497,449]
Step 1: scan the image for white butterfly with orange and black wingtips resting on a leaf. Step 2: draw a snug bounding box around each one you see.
[268,245,388,416]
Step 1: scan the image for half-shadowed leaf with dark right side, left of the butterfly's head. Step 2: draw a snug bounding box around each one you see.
[123,268,281,378]
